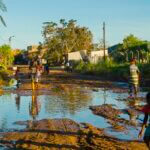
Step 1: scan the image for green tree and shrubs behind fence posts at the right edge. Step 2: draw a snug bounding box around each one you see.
[111,34,149,62]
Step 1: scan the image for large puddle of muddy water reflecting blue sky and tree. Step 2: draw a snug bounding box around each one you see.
[0,85,145,139]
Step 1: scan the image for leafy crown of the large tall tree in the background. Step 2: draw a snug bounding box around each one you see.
[43,19,92,64]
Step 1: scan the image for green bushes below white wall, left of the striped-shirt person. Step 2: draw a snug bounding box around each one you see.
[74,59,129,80]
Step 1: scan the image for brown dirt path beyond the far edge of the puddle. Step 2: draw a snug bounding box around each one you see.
[14,66,127,92]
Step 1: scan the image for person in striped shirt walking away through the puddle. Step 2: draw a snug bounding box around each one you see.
[129,58,140,98]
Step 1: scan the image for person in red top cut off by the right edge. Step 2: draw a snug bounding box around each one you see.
[138,92,150,148]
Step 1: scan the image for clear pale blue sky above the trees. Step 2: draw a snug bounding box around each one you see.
[0,0,150,49]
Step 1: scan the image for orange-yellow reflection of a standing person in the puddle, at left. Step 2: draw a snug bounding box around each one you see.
[29,91,40,120]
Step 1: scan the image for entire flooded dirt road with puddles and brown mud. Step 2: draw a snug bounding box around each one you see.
[0,68,147,149]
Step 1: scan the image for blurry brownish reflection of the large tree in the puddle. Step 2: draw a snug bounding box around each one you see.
[45,85,92,115]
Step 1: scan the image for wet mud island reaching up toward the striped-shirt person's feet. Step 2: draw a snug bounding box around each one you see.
[89,98,143,132]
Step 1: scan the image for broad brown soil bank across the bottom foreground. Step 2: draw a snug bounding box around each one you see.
[0,119,147,150]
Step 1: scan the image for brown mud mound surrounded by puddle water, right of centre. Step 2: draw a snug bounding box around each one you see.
[90,104,142,132]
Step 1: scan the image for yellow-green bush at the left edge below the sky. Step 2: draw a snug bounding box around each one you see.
[0,45,14,67]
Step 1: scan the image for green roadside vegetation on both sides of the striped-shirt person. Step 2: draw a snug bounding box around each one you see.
[73,59,150,86]
